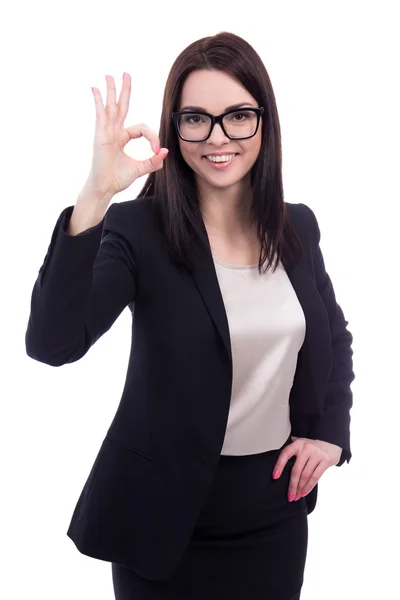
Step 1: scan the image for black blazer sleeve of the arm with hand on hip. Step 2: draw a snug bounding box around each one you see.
[307,207,355,467]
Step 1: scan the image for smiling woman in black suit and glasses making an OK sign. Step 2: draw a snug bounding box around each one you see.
[26,33,354,600]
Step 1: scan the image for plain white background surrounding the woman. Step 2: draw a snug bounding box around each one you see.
[0,0,400,600]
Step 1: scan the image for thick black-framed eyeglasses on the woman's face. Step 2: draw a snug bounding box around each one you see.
[172,106,264,142]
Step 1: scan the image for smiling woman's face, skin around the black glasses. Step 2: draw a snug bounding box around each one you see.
[178,70,262,193]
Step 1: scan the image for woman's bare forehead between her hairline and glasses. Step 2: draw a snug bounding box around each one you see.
[179,69,257,114]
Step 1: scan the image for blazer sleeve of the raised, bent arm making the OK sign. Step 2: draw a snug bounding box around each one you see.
[25,203,136,367]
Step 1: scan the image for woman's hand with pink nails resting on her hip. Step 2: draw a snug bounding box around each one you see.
[273,436,342,502]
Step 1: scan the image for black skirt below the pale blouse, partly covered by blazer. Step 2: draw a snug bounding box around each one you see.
[112,436,308,600]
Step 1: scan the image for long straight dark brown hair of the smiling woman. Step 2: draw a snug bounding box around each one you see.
[138,32,303,274]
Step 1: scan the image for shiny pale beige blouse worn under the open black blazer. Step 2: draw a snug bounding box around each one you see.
[213,256,306,455]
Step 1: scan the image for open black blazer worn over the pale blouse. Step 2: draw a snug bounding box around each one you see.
[26,198,354,580]
